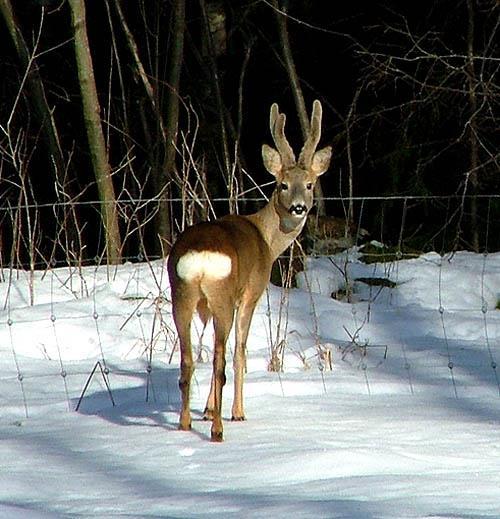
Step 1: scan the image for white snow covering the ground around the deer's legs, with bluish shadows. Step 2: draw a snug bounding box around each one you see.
[0,249,500,519]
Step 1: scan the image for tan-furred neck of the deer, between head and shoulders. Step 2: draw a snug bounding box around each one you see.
[246,192,306,261]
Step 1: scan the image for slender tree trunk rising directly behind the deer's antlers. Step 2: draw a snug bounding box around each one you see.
[272,0,325,215]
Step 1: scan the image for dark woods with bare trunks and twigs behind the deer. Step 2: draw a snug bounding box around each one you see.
[0,0,500,267]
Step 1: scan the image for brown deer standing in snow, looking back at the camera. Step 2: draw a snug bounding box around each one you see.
[167,100,332,442]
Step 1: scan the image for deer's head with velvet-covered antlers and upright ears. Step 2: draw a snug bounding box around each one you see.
[262,100,332,224]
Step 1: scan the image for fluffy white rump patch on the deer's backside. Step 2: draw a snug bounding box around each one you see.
[176,251,231,281]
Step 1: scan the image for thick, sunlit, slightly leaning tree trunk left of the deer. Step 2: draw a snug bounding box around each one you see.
[69,0,121,264]
